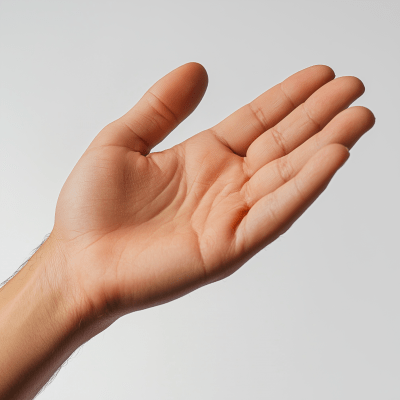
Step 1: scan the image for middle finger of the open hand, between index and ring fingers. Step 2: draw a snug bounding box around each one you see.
[245,76,365,174]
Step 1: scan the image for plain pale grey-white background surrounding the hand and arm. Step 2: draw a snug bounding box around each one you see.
[0,0,400,400]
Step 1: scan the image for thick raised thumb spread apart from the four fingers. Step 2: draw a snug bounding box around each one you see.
[92,62,208,154]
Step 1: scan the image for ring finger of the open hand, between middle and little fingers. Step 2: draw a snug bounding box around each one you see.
[242,107,375,206]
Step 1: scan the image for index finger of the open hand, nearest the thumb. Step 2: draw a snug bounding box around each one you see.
[211,65,335,156]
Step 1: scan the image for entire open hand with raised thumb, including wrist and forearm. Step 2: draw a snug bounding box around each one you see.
[0,63,375,399]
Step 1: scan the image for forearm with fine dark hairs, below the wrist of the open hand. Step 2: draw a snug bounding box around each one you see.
[0,234,101,400]
